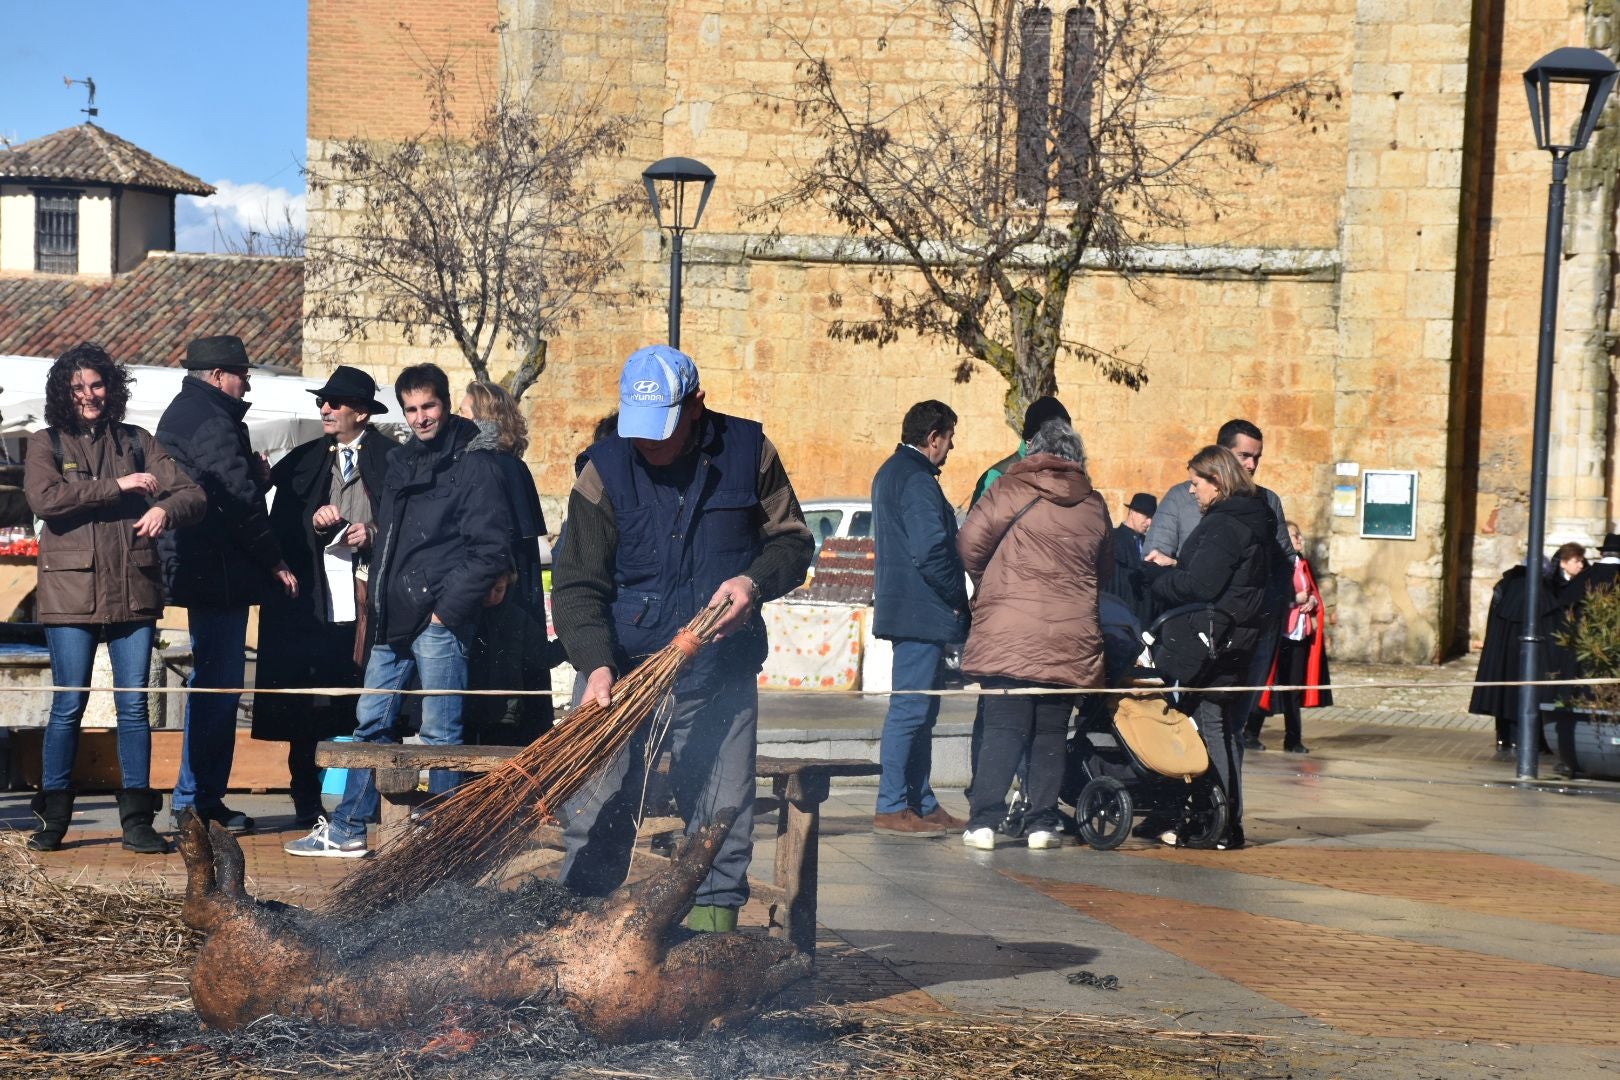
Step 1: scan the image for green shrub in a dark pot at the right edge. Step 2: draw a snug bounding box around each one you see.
[1542,583,1620,780]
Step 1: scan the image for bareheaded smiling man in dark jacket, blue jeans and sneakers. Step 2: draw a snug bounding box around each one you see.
[284,364,512,858]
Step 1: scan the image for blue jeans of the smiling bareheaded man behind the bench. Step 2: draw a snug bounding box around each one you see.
[330,622,471,844]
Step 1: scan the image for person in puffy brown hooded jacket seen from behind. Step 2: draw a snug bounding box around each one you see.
[956,419,1113,850]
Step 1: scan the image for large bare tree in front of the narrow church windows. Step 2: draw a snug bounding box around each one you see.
[752,0,1337,429]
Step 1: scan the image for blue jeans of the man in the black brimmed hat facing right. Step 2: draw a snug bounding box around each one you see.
[168,607,248,814]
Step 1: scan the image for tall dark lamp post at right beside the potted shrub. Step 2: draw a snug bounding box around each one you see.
[1518,49,1620,780]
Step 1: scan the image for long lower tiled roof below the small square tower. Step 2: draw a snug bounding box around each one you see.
[0,251,303,371]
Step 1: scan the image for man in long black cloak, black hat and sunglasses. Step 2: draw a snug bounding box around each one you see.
[253,366,399,829]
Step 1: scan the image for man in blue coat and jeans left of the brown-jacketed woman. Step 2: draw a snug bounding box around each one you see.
[872,400,967,836]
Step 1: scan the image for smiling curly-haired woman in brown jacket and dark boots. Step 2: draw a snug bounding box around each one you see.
[23,342,204,855]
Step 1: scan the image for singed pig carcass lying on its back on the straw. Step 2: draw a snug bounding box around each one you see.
[180,814,810,1043]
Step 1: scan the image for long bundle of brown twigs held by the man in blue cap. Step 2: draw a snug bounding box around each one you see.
[326,599,731,916]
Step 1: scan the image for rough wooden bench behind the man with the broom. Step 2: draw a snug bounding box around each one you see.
[314,742,880,952]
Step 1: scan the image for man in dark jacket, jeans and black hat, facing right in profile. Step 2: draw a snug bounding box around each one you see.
[156,335,298,832]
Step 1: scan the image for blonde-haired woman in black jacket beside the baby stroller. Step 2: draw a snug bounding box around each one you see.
[1153,445,1277,850]
